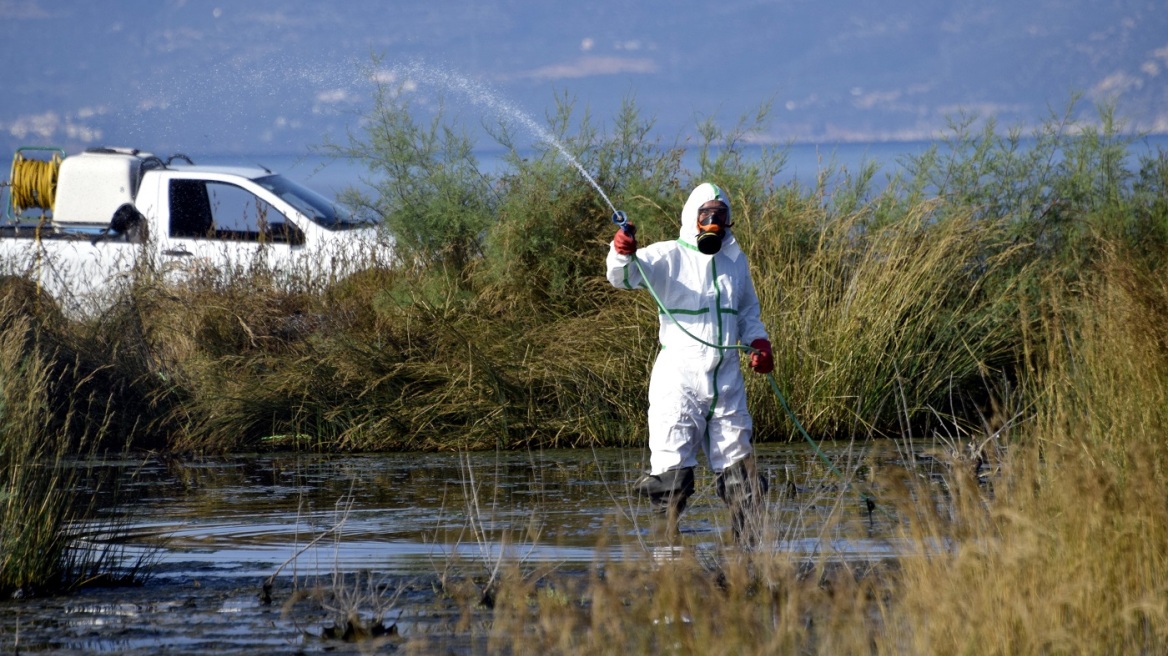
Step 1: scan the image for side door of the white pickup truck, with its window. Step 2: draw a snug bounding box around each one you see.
[161,179,305,273]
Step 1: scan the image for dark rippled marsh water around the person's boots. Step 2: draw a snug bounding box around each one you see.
[0,445,929,654]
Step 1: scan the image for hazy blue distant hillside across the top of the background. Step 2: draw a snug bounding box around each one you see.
[0,0,1168,153]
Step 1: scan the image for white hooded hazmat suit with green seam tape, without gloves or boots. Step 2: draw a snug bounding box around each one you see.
[607,182,767,487]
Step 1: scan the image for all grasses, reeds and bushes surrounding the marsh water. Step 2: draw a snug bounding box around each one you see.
[0,88,1168,654]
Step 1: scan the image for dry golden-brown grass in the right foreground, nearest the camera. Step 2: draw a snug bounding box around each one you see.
[471,246,1168,655]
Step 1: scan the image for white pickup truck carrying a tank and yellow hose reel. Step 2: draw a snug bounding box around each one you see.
[0,148,391,315]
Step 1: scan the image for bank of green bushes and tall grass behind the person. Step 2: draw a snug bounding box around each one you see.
[13,88,1168,451]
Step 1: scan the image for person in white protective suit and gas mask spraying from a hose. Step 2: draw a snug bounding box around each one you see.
[607,182,774,544]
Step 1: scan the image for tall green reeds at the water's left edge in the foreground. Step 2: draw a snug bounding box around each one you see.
[0,288,142,596]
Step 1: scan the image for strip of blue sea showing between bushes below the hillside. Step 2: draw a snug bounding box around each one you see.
[192,135,1168,198]
